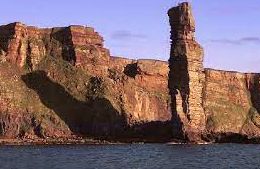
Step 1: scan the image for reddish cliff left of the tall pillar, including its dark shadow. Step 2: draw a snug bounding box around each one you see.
[0,23,171,140]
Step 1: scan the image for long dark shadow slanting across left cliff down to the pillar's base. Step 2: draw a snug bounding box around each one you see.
[22,71,175,142]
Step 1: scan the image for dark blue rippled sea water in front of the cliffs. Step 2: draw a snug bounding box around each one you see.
[0,144,260,169]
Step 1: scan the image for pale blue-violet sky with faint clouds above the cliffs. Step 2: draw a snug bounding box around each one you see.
[0,0,260,72]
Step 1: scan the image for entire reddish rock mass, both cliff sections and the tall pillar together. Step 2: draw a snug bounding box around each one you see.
[0,3,260,142]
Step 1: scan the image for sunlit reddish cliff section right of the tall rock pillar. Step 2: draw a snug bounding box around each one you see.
[204,69,260,137]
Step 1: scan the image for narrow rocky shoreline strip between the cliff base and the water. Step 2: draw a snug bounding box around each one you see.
[0,133,260,146]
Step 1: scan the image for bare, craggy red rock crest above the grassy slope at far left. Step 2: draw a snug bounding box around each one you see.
[0,23,109,74]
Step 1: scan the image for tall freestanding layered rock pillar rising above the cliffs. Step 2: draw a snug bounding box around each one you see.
[168,2,205,142]
